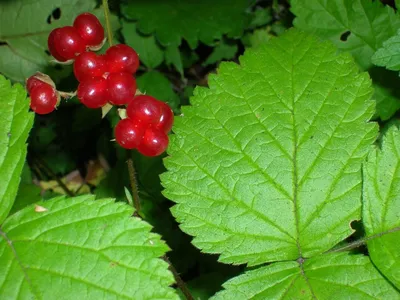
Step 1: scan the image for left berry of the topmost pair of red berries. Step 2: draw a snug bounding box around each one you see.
[48,26,86,61]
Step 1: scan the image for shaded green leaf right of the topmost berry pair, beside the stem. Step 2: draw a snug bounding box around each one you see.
[122,21,164,68]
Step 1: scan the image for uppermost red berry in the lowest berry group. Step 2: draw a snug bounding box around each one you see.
[126,95,162,126]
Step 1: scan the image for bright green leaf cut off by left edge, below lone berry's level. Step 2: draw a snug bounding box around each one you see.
[0,75,34,224]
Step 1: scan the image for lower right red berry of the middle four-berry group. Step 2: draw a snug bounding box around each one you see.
[107,72,136,105]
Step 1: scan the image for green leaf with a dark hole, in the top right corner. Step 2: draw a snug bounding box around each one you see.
[291,0,400,70]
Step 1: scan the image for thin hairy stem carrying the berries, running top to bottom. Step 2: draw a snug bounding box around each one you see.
[102,0,194,300]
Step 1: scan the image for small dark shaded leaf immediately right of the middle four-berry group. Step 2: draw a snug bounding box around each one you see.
[136,71,179,110]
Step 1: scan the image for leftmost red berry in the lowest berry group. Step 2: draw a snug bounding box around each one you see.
[115,118,145,149]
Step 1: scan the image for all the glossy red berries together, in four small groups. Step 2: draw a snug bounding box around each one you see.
[26,13,174,156]
